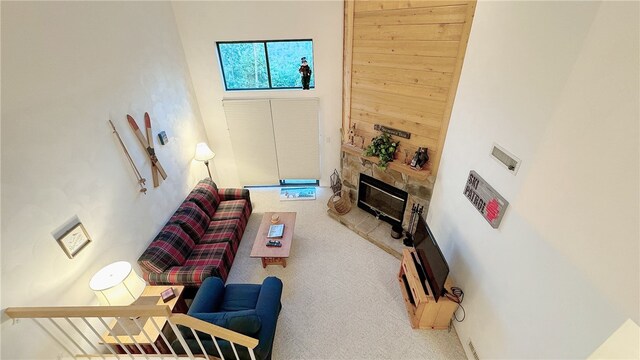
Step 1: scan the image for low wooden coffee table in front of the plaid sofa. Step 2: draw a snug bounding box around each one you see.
[251,212,296,268]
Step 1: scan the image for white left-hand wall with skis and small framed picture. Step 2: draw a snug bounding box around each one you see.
[1,2,206,359]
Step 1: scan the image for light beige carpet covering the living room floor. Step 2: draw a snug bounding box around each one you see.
[227,188,466,360]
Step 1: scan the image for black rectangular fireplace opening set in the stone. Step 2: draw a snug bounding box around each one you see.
[358,173,409,227]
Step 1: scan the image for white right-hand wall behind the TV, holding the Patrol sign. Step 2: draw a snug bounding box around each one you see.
[428,1,640,359]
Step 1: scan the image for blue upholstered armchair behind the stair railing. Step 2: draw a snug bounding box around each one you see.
[172,277,282,360]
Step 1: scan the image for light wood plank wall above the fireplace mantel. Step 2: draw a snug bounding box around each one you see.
[343,0,476,176]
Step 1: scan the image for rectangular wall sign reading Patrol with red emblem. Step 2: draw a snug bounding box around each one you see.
[462,170,509,229]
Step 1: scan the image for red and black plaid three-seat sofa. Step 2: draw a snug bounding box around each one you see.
[138,178,252,286]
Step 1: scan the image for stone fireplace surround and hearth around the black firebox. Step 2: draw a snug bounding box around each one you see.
[328,151,433,259]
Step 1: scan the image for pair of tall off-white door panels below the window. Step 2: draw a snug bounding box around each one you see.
[222,98,320,185]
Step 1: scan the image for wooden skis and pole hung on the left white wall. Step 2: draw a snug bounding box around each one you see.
[109,113,167,194]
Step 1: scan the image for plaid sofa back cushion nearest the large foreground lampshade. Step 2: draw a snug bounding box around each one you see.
[138,224,195,273]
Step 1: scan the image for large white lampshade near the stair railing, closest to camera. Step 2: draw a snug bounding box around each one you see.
[89,261,147,306]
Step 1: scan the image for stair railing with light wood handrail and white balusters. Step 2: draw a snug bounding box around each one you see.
[5,305,258,360]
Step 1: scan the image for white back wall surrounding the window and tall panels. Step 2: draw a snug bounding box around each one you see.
[173,1,343,186]
